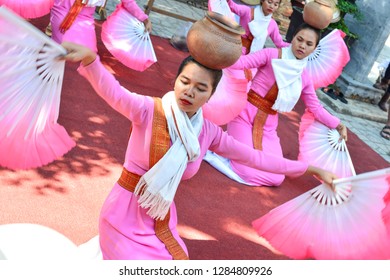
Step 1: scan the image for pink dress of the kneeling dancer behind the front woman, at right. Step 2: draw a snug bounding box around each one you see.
[227,48,340,186]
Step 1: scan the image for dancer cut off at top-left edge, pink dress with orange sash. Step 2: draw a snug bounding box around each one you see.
[50,0,152,52]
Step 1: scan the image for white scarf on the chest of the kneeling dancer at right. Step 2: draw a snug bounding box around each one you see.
[271,46,307,113]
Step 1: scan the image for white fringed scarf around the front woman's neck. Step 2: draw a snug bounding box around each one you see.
[134,91,203,220]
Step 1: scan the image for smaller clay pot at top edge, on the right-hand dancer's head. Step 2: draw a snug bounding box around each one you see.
[303,0,333,29]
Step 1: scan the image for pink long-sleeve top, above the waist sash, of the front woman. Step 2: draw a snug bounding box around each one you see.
[78,58,308,179]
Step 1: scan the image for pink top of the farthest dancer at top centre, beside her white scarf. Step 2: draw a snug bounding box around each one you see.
[228,0,289,48]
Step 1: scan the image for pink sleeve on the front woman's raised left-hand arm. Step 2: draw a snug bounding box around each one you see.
[77,56,153,123]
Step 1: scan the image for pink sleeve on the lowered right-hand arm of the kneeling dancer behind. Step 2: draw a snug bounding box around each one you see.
[301,71,340,128]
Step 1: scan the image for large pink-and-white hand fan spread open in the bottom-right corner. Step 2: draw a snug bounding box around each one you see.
[252,168,390,259]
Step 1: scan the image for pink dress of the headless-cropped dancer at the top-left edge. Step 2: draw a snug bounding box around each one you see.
[50,0,148,52]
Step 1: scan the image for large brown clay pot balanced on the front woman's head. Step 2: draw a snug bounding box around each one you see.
[187,11,245,69]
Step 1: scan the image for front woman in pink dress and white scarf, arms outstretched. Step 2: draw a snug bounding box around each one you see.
[62,42,335,259]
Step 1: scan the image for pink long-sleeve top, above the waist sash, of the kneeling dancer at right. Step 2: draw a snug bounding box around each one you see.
[231,48,340,128]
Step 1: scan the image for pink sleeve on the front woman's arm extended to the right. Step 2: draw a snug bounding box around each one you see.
[208,122,309,177]
